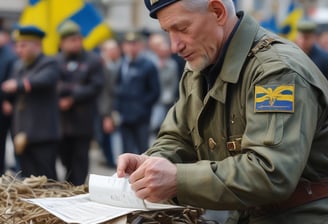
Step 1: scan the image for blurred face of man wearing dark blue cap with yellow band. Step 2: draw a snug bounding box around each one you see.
[15,40,41,63]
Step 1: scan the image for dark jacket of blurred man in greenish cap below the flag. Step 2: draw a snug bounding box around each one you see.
[57,51,104,137]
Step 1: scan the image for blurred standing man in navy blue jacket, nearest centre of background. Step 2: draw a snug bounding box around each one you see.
[115,32,160,154]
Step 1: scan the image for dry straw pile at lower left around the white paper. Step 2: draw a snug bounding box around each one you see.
[0,174,87,224]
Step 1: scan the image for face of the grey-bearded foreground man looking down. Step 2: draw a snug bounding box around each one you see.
[157,2,223,71]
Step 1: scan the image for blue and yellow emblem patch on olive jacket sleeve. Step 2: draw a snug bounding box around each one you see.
[254,85,295,113]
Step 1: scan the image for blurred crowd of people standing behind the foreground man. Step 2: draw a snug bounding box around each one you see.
[0,13,328,185]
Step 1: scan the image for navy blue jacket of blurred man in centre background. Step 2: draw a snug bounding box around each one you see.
[114,54,160,124]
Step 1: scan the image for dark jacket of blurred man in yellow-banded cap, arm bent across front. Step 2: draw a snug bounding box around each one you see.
[10,55,60,143]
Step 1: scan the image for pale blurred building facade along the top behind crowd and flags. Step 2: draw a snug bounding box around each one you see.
[0,0,328,32]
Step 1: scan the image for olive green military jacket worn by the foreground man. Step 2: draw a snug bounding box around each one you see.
[146,12,328,223]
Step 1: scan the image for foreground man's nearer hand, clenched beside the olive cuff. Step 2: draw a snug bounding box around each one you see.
[130,157,177,202]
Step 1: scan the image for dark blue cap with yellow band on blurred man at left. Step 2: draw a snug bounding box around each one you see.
[13,25,46,40]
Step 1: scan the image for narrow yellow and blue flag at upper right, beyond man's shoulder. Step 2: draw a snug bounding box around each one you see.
[280,0,304,41]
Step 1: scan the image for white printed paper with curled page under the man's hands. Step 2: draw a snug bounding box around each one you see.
[22,174,179,224]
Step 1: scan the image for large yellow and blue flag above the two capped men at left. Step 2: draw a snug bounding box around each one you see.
[20,0,111,55]
